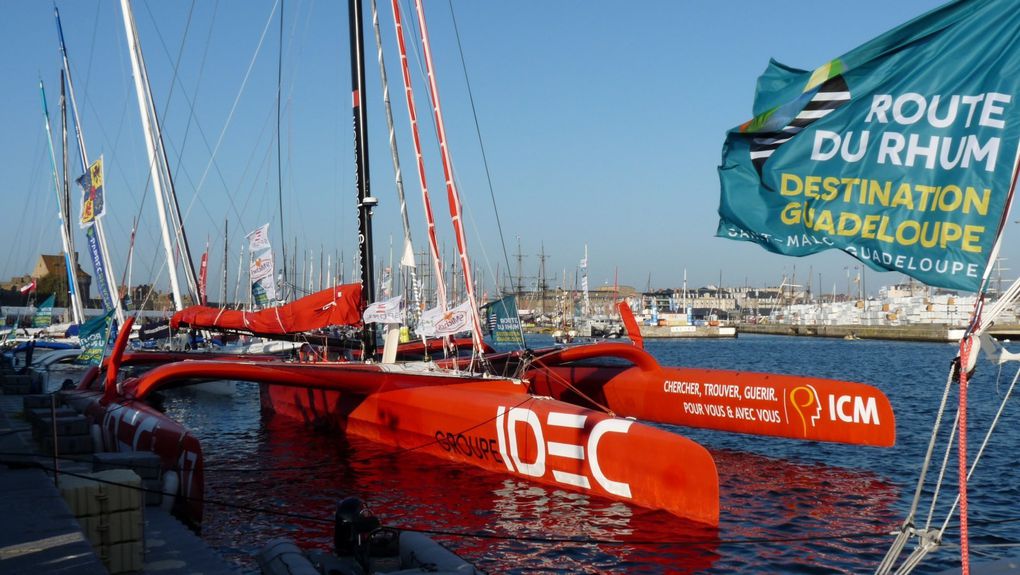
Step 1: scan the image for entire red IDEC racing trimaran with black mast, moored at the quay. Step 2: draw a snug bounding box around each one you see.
[71,0,895,525]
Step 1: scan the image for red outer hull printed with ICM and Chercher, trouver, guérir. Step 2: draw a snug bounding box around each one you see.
[454,344,896,447]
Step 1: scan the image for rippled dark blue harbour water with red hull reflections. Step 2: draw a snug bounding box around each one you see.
[155,335,1020,574]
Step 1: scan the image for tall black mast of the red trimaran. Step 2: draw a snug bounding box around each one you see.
[348,0,378,358]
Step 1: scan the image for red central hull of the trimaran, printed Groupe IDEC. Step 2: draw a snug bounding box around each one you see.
[261,370,719,526]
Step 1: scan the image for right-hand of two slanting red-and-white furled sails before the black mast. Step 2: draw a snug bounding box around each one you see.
[414,0,482,355]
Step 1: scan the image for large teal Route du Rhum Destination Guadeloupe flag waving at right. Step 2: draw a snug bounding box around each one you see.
[716,0,1020,292]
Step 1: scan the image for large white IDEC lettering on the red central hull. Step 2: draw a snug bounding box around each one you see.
[496,406,633,499]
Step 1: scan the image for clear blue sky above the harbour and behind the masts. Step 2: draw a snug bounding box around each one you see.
[7,0,983,305]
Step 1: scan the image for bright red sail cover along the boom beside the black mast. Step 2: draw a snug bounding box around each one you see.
[170,283,361,335]
